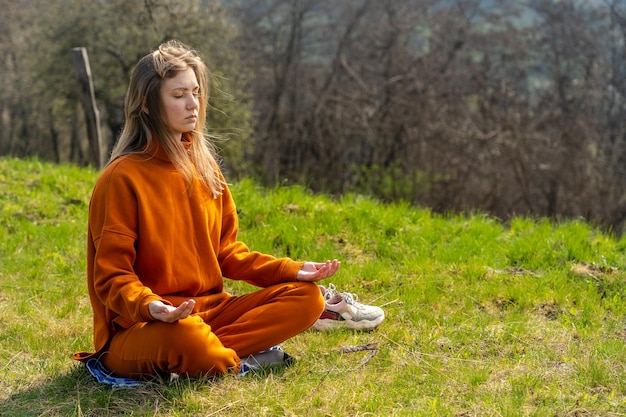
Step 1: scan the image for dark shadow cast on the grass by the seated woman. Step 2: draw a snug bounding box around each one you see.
[0,364,284,417]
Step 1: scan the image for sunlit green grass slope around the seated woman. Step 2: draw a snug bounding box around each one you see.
[0,158,626,417]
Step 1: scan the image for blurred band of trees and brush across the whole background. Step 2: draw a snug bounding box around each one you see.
[0,0,626,231]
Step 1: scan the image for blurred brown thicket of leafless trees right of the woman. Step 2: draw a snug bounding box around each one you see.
[234,0,626,228]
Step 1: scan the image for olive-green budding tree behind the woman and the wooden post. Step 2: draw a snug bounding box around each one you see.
[0,0,252,171]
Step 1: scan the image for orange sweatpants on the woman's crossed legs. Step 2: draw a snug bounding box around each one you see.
[100,282,324,378]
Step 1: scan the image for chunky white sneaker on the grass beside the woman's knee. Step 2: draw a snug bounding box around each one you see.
[312,284,385,331]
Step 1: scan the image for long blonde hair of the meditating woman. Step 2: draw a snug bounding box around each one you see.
[109,40,225,198]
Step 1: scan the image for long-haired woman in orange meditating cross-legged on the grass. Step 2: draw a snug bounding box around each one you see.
[75,41,340,378]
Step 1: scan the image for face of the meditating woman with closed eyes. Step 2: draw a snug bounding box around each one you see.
[160,68,199,135]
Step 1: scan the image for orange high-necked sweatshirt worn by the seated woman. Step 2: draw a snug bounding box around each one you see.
[75,140,303,359]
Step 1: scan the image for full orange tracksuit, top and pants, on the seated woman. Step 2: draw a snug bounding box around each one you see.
[74,139,324,377]
